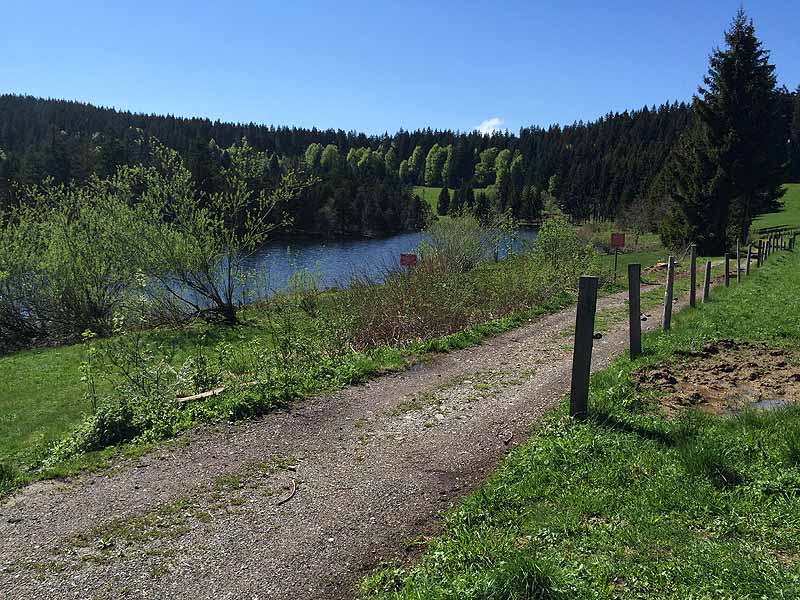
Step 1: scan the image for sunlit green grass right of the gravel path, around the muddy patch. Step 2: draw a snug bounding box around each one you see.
[362,254,800,600]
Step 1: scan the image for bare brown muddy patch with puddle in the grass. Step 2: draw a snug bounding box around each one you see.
[635,340,800,415]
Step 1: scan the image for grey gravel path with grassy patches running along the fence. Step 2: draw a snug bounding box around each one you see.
[0,284,682,600]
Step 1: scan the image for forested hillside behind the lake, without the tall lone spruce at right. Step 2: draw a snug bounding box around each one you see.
[0,88,800,236]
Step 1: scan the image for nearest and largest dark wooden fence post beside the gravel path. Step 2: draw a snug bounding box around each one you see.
[569,275,598,418]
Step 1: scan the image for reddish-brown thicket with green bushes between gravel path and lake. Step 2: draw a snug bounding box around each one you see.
[336,217,600,348]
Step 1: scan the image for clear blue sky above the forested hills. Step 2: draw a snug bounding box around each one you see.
[0,0,800,133]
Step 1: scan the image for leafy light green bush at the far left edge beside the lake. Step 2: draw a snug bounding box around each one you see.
[0,180,147,347]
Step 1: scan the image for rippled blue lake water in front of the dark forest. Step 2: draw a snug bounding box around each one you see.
[238,229,536,300]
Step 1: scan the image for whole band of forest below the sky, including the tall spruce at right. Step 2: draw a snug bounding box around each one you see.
[0,13,800,244]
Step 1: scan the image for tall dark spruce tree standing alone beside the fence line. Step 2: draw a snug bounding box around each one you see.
[661,9,785,254]
